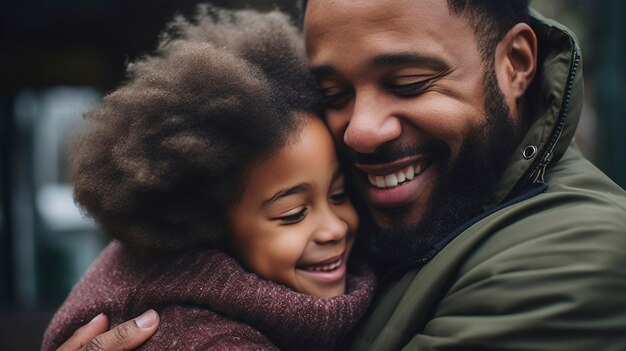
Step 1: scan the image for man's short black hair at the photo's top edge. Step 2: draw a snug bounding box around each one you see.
[298,0,529,62]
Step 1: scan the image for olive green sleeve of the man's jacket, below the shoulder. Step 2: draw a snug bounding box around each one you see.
[404,202,626,350]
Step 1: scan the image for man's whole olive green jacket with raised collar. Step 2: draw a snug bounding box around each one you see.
[352,13,626,351]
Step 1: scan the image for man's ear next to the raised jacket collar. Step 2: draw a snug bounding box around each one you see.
[495,23,537,100]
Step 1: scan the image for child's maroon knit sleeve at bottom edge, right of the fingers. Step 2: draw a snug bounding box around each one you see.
[140,305,278,351]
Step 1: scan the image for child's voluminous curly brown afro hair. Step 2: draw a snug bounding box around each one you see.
[71,5,321,250]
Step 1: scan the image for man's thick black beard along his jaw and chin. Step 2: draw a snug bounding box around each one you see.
[369,70,516,269]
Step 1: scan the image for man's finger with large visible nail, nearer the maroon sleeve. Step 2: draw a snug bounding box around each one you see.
[84,310,159,351]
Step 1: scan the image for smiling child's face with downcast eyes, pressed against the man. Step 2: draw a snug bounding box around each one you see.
[229,117,358,297]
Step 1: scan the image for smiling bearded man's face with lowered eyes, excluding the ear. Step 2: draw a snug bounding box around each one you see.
[304,0,514,264]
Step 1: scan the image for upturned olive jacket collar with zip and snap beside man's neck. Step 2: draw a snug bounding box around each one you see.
[485,10,583,209]
